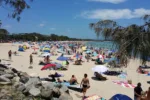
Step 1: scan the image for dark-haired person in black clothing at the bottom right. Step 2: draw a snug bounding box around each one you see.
[134,83,143,100]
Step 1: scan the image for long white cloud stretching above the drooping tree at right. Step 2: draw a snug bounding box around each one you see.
[81,8,150,19]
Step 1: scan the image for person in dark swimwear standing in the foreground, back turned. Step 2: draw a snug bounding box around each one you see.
[80,74,90,98]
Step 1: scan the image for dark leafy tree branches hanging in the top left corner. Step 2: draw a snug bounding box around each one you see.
[0,0,33,21]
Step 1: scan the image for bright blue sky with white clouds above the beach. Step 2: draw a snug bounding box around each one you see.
[0,0,150,39]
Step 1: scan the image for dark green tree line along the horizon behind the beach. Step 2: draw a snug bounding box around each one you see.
[0,29,93,41]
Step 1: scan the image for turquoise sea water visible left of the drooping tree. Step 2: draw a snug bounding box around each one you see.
[86,41,117,50]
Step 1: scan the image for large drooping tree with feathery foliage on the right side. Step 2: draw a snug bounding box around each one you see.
[90,15,150,63]
